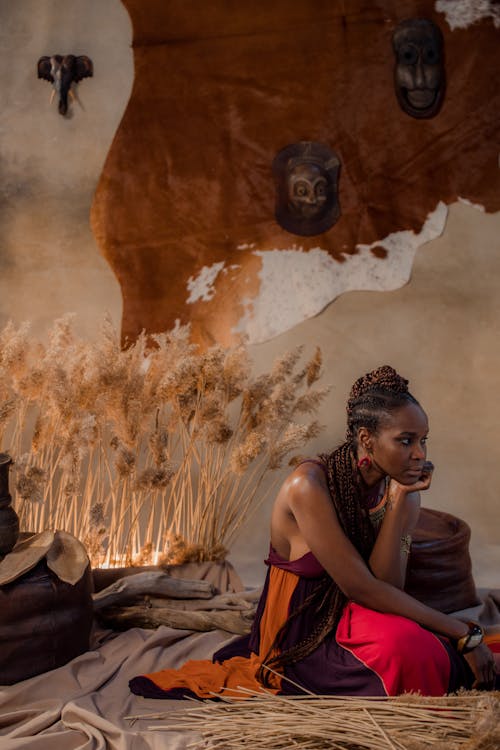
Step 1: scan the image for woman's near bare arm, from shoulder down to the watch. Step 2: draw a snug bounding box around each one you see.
[286,465,468,639]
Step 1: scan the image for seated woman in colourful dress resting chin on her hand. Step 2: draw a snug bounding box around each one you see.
[130,366,495,697]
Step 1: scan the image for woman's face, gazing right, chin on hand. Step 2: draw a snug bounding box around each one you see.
[370,404,429,484]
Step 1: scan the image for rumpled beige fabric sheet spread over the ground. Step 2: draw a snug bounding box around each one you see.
[0,589,500,750]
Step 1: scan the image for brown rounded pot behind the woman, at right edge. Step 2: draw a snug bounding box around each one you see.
[405,508,479,613]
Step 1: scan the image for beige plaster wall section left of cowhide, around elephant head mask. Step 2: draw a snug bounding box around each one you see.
[0,0,129,335]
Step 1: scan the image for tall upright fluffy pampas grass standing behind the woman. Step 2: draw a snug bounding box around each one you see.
[0,316,328,565]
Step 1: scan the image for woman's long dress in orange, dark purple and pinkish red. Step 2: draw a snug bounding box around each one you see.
[129,470,473,698]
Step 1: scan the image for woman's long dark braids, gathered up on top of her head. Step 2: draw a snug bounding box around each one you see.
[258,365,418,686]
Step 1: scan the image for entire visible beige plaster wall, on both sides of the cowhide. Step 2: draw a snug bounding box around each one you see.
[0,0,500,586]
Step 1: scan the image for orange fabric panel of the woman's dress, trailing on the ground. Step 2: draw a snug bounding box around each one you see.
[145,567,299,698]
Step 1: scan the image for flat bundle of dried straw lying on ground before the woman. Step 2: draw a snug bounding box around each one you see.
[127,689,500,750]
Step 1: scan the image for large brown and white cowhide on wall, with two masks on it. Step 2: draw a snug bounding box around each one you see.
[92,0,500,344]
